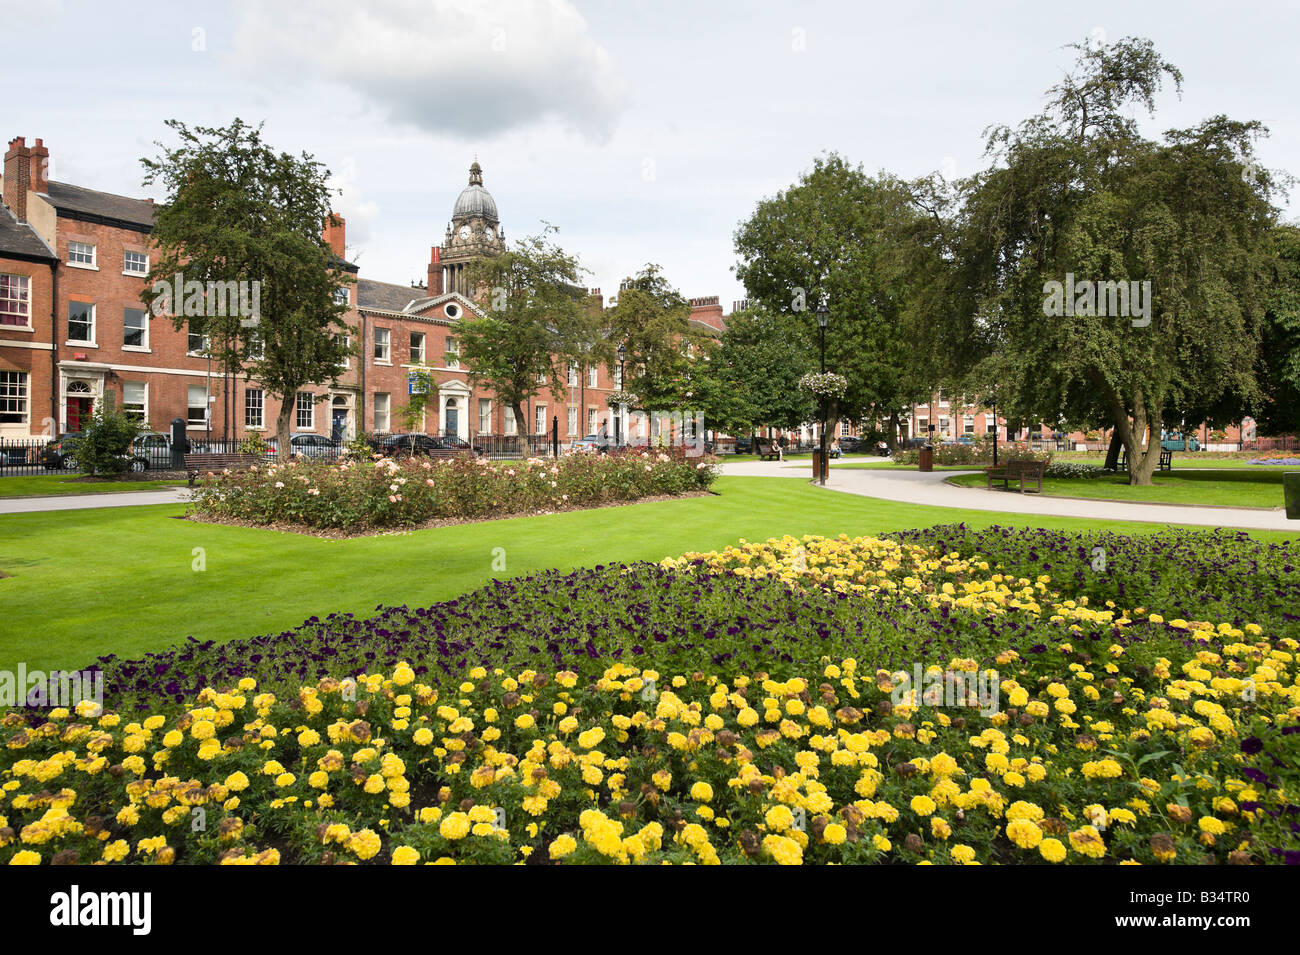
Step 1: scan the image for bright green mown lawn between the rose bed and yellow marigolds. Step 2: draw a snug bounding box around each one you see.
[0,477,1295,669]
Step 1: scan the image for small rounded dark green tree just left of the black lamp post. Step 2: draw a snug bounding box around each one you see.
[702,307,816,434]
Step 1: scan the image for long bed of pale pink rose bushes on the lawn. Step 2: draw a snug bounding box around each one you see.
[191,448,718,533]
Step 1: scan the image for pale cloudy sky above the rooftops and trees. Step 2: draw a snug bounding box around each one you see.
[0,0,1300,309]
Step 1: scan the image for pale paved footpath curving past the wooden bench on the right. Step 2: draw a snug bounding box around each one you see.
[723,459,1300,534]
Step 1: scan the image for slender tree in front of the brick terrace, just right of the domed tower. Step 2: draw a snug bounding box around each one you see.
[458,226,599,439]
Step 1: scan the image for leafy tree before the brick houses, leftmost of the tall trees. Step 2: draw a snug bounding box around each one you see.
[142,118,354,460]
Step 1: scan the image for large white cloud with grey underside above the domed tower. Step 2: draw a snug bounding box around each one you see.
[233,0,624,142]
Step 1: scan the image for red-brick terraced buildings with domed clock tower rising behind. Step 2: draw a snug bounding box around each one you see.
[0,138,723,449]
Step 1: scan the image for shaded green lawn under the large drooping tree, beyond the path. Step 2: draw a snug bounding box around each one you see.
[948,468,1286,508]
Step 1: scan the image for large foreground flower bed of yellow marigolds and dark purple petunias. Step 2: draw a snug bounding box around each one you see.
[0,526,1300,864]
